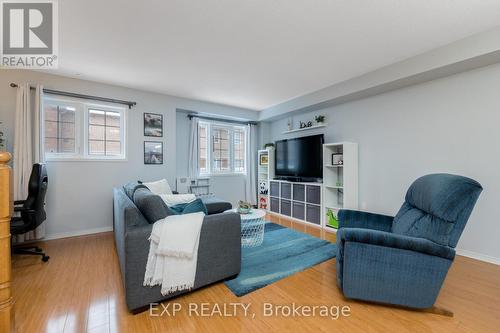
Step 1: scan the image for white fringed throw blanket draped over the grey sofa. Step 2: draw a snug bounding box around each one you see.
[144,212,205,296]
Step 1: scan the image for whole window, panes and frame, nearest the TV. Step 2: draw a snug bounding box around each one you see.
[198,121,247,175]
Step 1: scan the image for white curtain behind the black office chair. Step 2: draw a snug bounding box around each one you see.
[13,83,45,242]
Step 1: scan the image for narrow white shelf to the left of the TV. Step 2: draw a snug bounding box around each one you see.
[257,147,274,210]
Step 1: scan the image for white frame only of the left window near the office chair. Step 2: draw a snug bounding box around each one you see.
[40,96,128,161]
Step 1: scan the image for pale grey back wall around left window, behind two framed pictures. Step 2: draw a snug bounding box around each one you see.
[0,70,257,238]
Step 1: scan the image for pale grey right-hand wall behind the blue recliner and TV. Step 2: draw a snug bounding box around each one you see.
[270,64,500,263]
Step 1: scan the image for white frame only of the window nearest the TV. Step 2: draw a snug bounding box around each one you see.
[197,120,248,176]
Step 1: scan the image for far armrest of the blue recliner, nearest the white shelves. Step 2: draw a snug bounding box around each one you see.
[338,209,394,231]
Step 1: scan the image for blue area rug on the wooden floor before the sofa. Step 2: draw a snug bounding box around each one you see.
[224,222,337,296]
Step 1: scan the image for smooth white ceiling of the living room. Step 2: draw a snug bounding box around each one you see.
[51,0,500,110]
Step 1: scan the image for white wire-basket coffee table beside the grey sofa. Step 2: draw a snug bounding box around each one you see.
[228,209,266,247]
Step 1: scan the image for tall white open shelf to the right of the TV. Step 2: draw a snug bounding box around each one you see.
[322,142,358,232]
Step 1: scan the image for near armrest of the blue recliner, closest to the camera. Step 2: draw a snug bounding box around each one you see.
[337,228,455,260]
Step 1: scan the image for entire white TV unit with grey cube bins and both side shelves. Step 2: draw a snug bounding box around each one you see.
[258,142,358,232]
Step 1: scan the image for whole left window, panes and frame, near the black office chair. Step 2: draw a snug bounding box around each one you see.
[41,97,126,160]
